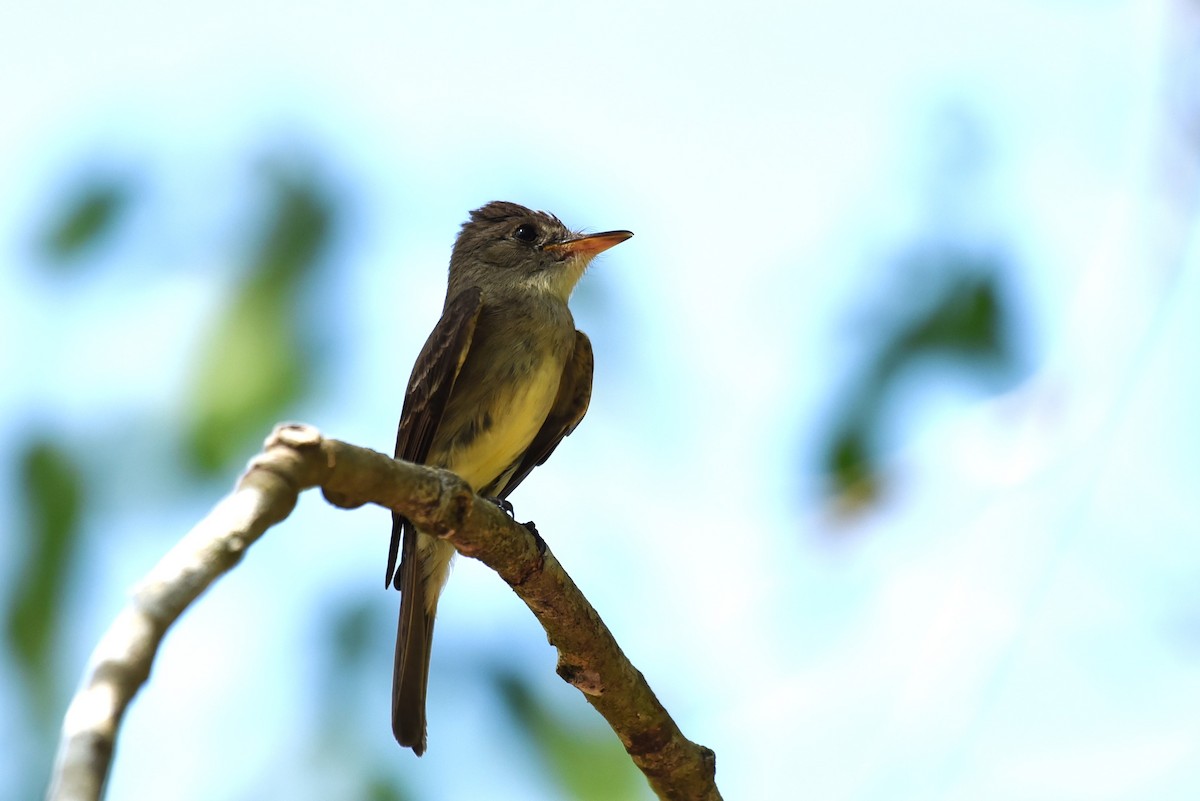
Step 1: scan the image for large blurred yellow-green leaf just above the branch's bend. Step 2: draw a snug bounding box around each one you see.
[187,163,332,475]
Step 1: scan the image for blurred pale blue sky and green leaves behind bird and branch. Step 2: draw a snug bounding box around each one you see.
[0,0,1200,801]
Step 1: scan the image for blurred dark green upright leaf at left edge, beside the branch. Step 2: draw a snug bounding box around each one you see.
[6,439,84,724]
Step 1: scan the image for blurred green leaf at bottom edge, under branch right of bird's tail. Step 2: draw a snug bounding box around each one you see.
[493,670,648,801]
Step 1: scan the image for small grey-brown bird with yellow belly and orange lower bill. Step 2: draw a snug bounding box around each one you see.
[385,200,632,757]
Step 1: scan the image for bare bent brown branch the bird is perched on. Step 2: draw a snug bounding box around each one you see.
[47,424,720,801]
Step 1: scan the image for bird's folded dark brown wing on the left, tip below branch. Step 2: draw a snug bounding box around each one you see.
[384,287,484,585]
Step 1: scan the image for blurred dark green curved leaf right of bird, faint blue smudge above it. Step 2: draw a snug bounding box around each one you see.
[817,101,1025,512]
